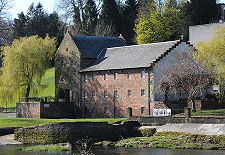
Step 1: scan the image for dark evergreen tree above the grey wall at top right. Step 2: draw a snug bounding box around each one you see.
[191,0,217,25]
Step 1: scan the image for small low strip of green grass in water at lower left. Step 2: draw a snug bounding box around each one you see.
[17,145,71,152]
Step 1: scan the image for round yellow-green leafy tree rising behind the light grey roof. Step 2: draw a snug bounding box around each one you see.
[135,1,184,44]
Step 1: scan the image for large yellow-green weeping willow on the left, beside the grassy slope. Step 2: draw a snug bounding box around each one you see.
[0,36,56,101]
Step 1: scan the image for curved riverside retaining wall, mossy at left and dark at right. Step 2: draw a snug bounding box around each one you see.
[14,122,140,144]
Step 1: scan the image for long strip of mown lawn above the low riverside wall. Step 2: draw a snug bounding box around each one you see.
[0,117,127,128]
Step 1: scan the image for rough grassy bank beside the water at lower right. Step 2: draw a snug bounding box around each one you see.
[98,132,225,150]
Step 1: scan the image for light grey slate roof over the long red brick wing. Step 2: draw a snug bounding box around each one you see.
[81,41,179,72]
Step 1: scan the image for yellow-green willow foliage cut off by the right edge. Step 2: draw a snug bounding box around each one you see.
[195,27,225,85]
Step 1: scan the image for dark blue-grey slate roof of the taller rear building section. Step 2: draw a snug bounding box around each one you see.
[72,35,126,58]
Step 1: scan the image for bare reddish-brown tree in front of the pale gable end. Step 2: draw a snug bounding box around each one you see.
[156,50,214,101]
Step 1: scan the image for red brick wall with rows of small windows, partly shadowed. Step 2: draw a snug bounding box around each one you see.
[81,69,149,117]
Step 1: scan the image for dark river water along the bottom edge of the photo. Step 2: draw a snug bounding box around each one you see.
[0,146,225,155]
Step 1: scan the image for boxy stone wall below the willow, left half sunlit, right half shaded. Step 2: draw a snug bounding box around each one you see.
[16,102,78,118]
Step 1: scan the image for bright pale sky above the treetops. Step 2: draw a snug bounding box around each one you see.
[6,0,225,19]
